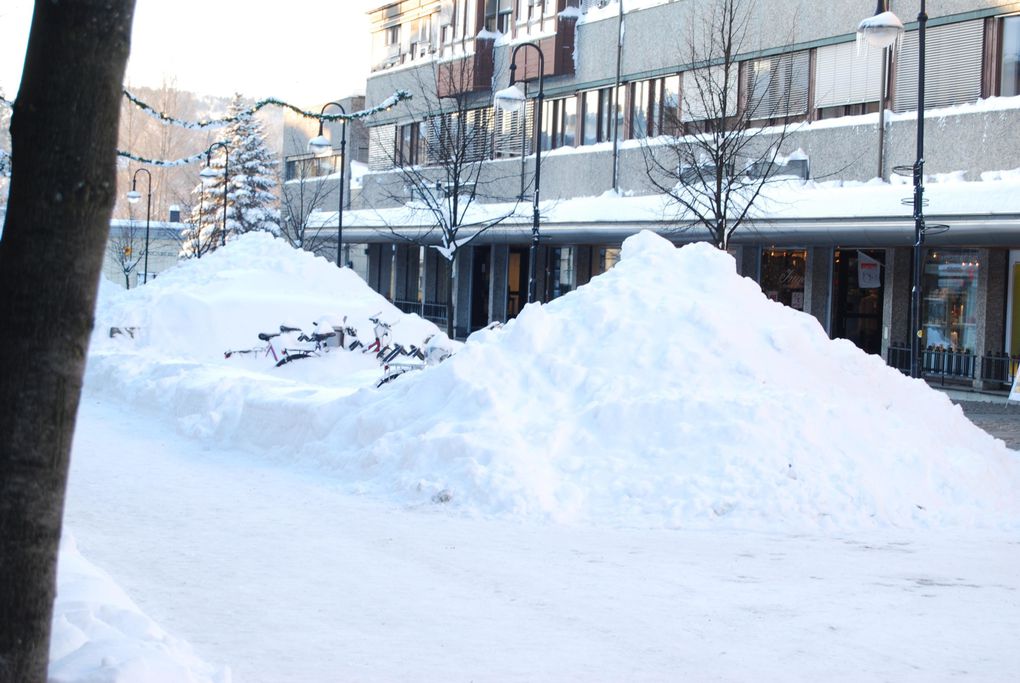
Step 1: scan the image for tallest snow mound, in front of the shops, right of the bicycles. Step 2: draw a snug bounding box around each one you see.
[329,232,1020,528]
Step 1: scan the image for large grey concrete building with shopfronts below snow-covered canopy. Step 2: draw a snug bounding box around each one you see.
[306,0,1020,387]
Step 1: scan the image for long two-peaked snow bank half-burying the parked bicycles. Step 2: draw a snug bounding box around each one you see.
[89,232,1020,529]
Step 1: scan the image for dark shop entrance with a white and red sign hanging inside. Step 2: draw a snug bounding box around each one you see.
[832,249,885,354]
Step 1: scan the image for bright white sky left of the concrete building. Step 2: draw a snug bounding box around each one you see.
[0,0,378,107]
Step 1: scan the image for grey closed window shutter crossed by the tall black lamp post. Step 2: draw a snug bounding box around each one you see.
[895,19,984,111]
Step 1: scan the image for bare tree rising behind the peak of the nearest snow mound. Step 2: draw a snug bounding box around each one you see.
[642,0,808,249]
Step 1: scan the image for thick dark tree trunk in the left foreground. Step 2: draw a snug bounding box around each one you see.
[0,0,135,683]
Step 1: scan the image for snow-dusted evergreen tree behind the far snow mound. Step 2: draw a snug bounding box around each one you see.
[181,95,281,258]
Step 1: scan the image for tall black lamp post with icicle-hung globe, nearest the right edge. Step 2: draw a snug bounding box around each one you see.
[857,0,928,377]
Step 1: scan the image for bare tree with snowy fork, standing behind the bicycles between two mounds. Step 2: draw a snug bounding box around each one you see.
[367,60,524,337]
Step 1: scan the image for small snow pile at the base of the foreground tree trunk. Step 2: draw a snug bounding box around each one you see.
[49,530,231,683]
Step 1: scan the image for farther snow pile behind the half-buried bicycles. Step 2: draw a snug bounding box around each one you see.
[94,232,439,359]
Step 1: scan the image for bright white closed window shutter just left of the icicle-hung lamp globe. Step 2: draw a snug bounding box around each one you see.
[815,43,883,109]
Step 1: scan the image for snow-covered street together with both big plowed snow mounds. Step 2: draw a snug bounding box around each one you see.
[52,233,1020,682]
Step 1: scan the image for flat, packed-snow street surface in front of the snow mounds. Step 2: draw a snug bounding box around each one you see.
[66,393,1020,683]
